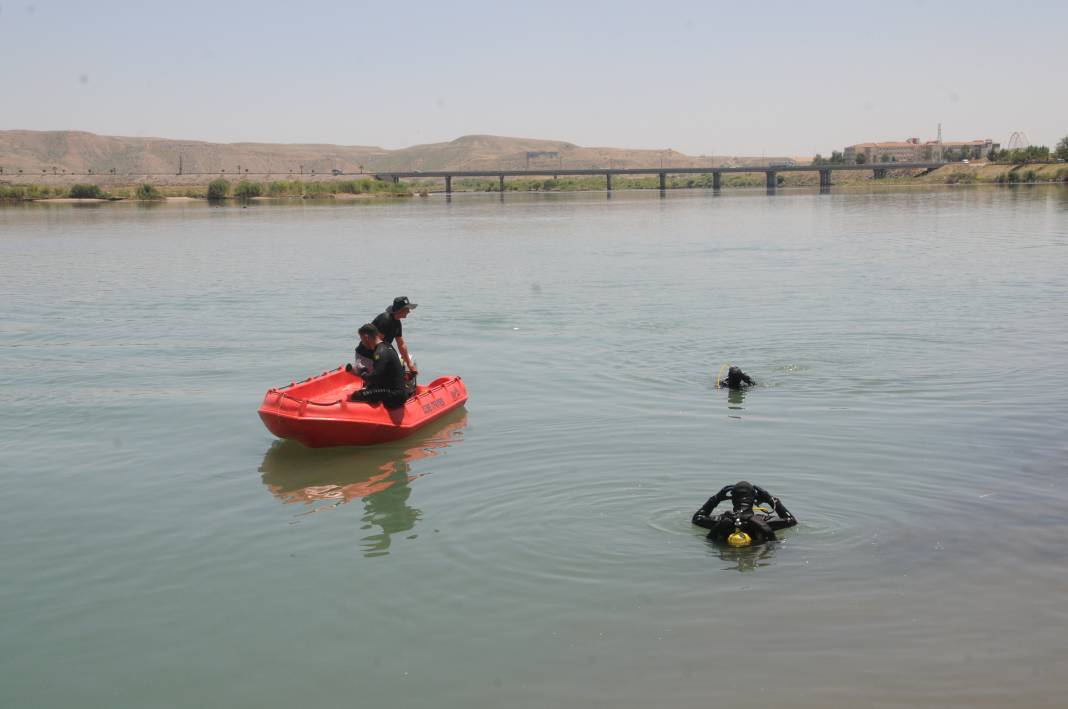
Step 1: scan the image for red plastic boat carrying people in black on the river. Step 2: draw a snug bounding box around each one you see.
[260,367,467,448]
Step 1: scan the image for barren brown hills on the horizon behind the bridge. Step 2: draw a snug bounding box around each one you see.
[0,130,785,179]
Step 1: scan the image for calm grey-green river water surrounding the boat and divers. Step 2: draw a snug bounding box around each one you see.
[6,187,1068,709]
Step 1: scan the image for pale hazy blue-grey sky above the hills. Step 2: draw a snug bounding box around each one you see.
[0,0,1068,155]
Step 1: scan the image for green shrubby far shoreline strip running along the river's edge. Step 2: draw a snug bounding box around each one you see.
[0,163,1068,202]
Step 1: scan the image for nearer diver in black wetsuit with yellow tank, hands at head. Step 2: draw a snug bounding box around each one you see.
[691,480,798,547]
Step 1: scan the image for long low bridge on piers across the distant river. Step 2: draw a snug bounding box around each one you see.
[373,162,947,194]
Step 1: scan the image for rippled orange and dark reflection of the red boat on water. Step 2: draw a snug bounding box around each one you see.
[260,409,467,556]
